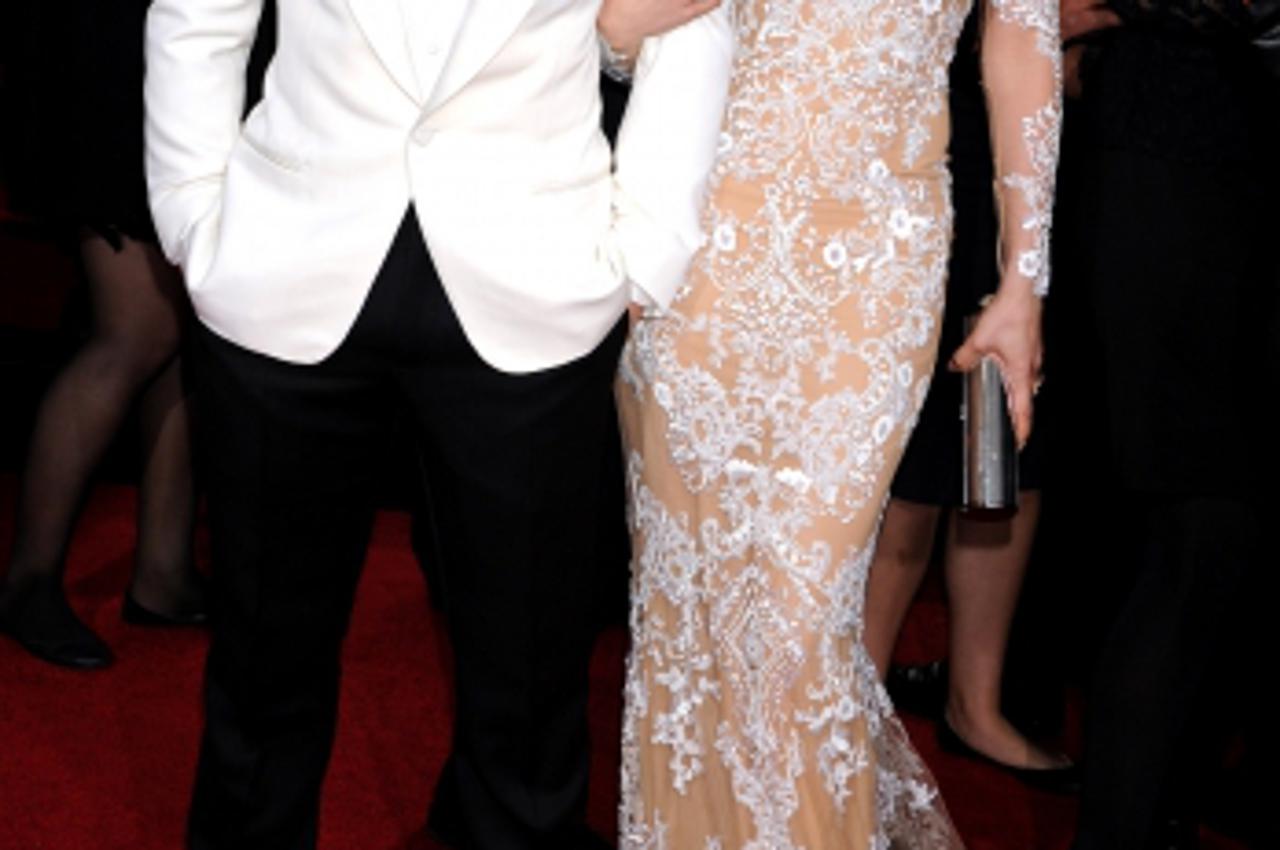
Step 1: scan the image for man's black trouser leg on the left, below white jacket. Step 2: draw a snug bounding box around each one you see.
[189,325,381,850]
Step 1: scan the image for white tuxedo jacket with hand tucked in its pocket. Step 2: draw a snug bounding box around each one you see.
[146,0,732,373]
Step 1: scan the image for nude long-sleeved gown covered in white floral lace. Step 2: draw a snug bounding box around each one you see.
[618,0,1061,850]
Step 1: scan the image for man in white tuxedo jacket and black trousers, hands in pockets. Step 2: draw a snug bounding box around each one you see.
[146,0,731,850]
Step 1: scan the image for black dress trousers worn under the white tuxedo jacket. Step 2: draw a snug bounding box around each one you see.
[189,210,625,850]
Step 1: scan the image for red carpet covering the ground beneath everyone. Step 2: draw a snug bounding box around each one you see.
[0,476,1230,850]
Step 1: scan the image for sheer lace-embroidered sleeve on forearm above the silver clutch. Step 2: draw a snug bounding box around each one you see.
[982,0,1062,297]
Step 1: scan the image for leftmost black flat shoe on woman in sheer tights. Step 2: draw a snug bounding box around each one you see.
[0,581,115,670]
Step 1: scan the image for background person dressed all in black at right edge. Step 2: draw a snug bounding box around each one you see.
[1059,0,1280,850]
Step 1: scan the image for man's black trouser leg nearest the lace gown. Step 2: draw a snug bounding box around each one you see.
[414,320,622,850]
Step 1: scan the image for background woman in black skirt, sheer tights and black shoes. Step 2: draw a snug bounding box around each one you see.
[0,0,259,667]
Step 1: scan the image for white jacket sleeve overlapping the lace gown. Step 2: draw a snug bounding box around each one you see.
[613,0,733,309]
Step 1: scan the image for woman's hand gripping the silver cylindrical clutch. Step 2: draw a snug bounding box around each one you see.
[951,280,1043,449]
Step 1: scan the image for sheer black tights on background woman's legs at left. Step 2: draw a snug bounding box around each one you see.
[0,232,198,612]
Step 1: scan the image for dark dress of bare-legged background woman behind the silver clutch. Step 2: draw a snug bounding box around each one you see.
[890,14,1046,507]
